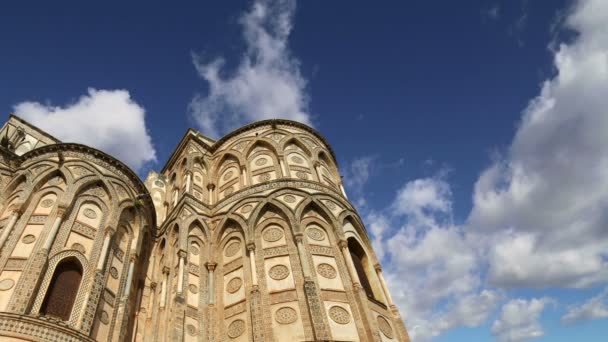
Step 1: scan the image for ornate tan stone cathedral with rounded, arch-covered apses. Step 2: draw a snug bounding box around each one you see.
[0,115,409,342]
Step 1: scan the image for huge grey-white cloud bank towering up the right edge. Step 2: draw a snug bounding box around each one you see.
[469,0,608,287]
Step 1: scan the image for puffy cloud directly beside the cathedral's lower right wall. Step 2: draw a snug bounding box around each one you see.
[366,177,502,341]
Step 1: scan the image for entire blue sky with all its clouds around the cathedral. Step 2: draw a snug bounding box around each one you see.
[0,0,608,341]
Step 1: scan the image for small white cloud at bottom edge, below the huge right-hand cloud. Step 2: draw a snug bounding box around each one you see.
[492,297,553,342]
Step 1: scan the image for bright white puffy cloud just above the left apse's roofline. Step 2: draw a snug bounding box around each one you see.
[14,89,156,171]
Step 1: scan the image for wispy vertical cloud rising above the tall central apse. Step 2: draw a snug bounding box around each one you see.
[190,0,311,137]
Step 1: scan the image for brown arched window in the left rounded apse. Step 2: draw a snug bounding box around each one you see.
[40,259,82,321]
